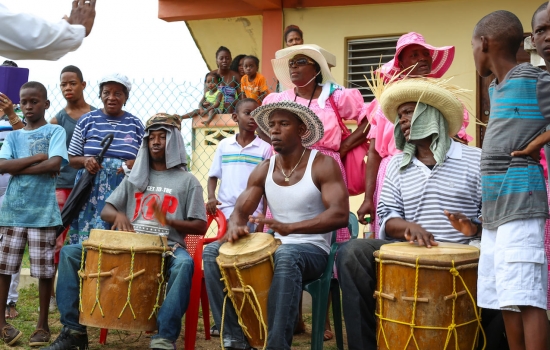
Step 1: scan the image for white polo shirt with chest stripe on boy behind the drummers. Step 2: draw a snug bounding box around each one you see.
[208,135,272,219]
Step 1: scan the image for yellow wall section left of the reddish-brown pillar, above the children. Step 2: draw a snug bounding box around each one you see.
[187,16,262,69]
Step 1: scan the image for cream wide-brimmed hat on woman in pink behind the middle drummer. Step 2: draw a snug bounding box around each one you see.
[271,44,336,89]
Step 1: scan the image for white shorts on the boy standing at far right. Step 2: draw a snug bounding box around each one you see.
[477,218,548,311]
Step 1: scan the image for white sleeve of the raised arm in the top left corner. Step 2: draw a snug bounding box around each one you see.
[0,4,86,61]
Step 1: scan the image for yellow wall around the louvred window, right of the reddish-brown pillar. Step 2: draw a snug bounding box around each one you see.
[284,0,542,145]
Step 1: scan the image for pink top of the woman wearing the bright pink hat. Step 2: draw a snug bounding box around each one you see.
[367,99,473,158]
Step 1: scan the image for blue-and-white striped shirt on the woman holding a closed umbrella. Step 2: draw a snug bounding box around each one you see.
[69,109,145,160]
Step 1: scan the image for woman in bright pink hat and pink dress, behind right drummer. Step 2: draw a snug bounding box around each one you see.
[357,32,472,238]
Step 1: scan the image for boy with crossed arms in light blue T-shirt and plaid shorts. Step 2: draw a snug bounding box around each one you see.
[0,82,68,346]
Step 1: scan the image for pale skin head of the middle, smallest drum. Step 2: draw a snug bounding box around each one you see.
[219,232,281,263]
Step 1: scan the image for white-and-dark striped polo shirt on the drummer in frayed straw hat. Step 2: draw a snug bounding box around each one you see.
[377,141,481,244]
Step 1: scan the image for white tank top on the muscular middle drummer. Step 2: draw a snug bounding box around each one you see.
[265,150,330,253]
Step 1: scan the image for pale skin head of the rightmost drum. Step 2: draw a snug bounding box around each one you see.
[380,242,479,262]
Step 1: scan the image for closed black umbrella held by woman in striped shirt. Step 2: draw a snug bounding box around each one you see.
[57,133,115,237]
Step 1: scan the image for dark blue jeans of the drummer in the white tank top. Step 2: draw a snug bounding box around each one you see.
[202,242,328,350]
